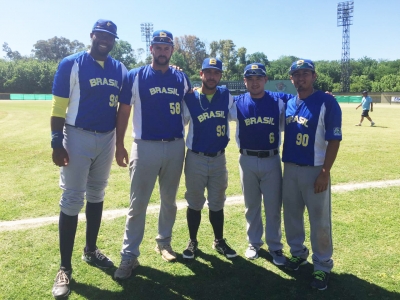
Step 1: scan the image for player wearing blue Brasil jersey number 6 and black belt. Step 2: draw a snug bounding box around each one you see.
[231,63,293,265]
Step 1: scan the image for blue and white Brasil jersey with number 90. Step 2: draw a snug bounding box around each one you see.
[282,91,342,166]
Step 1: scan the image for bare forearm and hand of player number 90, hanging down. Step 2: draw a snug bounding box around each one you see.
[314,140,340,194]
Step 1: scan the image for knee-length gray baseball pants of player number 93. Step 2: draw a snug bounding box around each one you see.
[185,149,228,211]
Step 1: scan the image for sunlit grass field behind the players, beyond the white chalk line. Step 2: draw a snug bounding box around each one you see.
[0,100,400,221]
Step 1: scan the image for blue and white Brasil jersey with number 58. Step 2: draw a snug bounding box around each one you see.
[121,65,191,140]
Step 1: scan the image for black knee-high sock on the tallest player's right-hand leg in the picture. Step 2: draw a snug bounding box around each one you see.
[85,202,103,252]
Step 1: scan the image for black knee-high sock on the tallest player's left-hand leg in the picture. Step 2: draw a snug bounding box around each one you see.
[58,212,78,270]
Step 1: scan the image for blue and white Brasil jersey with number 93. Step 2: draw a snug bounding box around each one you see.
[183,86,233,153]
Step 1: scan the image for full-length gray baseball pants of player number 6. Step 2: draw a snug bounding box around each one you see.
[239,154,283,251]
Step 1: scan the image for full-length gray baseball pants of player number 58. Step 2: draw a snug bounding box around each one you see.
[121,139,185,260]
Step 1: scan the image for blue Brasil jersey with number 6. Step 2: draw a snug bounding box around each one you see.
[234,91,294,151]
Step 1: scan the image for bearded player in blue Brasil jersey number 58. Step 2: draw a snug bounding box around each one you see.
[114,30,191,279]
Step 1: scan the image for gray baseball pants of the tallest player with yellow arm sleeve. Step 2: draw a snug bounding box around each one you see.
[60,125,115,216]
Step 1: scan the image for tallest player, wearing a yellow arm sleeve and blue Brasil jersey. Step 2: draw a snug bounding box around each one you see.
[51,20,127,298]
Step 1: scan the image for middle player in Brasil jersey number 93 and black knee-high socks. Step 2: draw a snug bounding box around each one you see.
[182,58,237,259]
